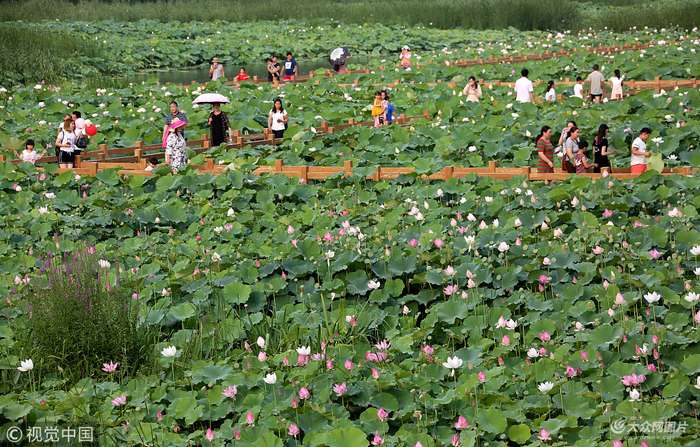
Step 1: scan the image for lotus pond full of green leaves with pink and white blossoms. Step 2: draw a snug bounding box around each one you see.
[0,22,700,447]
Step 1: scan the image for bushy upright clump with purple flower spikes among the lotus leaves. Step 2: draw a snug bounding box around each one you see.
[21,249,152,380]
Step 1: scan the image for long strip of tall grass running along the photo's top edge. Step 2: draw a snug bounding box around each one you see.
[0,0,576,30]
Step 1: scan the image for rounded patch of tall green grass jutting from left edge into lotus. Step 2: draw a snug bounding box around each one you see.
[0,23,100,83]
